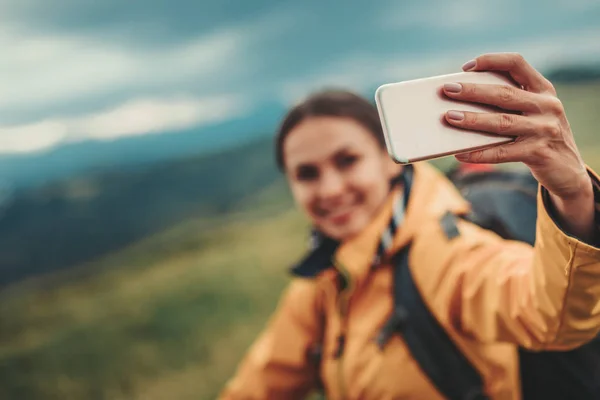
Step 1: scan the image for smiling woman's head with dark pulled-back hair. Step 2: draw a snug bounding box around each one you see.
[276,92,400,240]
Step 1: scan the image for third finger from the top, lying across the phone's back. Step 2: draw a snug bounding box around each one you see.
[445,110,541,136]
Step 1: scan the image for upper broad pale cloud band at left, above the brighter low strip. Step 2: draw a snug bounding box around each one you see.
[0,30,248,112]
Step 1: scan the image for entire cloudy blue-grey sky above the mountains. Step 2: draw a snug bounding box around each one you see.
[0,0,600,154]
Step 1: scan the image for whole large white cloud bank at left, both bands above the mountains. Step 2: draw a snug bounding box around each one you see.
[0,7,294,154]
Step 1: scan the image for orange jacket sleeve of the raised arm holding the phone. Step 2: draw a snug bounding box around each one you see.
[413,167,600,350]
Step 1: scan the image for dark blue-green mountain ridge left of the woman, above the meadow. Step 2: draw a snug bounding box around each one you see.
[0,134,290,286]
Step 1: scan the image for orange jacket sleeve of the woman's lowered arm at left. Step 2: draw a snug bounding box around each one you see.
[219,278,320,400]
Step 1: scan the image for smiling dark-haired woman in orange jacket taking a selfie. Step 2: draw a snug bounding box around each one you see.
[221,54,600,400]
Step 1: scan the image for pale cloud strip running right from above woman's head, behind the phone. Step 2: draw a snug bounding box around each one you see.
[276,27,600,104]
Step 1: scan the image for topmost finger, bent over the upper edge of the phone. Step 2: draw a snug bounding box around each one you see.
[463,53,553,93]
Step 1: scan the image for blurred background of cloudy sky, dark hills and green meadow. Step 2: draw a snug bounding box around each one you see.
[0,0,600,400]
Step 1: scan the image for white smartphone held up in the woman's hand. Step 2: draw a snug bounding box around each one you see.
[375,71,519,164]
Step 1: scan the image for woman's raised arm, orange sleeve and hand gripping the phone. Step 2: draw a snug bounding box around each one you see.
[414,54,600,349]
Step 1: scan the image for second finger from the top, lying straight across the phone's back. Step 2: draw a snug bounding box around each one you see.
[444,82,554,113]
